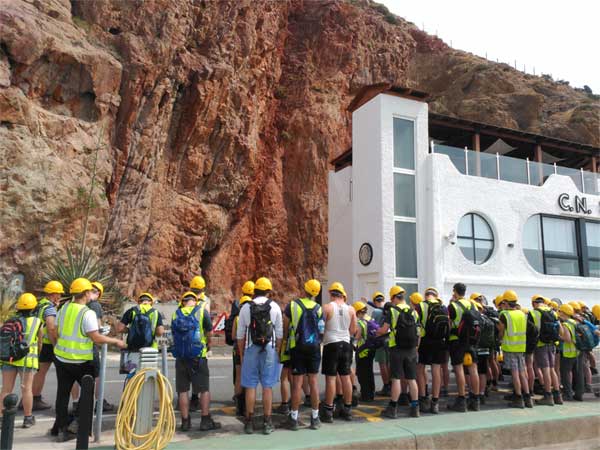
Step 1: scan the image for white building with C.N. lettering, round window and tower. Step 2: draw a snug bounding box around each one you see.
[328,84,600,304]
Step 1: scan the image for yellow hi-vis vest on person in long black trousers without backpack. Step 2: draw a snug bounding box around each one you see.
[54,301,94,361]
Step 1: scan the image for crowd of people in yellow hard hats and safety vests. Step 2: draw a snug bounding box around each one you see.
[0,276,600,441]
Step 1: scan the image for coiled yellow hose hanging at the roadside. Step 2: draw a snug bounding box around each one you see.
[115,369,175,450]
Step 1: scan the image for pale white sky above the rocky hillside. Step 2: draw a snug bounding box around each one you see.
[379,0,600,94]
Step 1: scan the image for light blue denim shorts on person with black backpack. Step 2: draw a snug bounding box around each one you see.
[242,344,281,389]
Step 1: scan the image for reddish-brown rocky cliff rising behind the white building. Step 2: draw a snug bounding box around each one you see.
[0,0,600,310]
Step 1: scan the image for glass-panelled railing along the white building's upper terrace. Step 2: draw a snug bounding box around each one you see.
[431,142,600,195]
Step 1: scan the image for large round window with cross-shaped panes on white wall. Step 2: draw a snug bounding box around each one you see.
[457,213,494,264]
